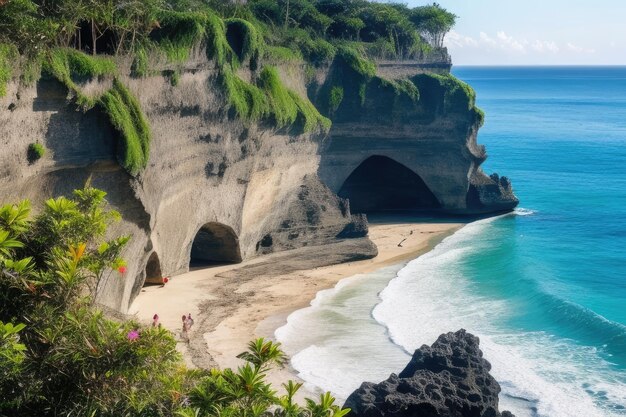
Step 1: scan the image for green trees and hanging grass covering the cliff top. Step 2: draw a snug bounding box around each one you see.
[0,0,473,175]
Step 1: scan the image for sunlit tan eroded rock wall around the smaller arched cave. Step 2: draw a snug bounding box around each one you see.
[0,61,364,311]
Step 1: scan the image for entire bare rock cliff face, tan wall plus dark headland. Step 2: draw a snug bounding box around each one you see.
[0,52,516,311]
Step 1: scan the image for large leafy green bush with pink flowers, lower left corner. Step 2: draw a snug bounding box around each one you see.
[0,187,187,416]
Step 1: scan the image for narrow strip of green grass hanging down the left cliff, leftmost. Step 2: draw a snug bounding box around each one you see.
[100,79,150,175]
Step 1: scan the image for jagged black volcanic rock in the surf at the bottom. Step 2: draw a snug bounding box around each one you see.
[344,330,513,417]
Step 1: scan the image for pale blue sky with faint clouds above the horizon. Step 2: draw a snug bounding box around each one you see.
[405,0,626,65]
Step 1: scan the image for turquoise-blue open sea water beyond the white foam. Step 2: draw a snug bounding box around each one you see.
[455,64,626,360]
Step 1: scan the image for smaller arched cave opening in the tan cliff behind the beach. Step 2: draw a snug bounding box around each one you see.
[189,223,242,267]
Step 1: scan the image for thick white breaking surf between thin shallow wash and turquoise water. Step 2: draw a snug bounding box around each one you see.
[374,221,626,417]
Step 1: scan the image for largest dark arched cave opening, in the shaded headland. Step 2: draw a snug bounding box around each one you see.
[337,155,441,213]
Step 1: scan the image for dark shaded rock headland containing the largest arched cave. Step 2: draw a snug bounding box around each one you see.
[311,63,518,215]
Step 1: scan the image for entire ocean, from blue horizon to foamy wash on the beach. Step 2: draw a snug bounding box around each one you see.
[276,67,626,417]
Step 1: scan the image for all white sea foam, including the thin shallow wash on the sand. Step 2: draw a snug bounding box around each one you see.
[276,219,626,417]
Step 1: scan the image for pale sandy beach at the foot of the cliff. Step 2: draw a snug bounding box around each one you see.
[129,217,463,382]
